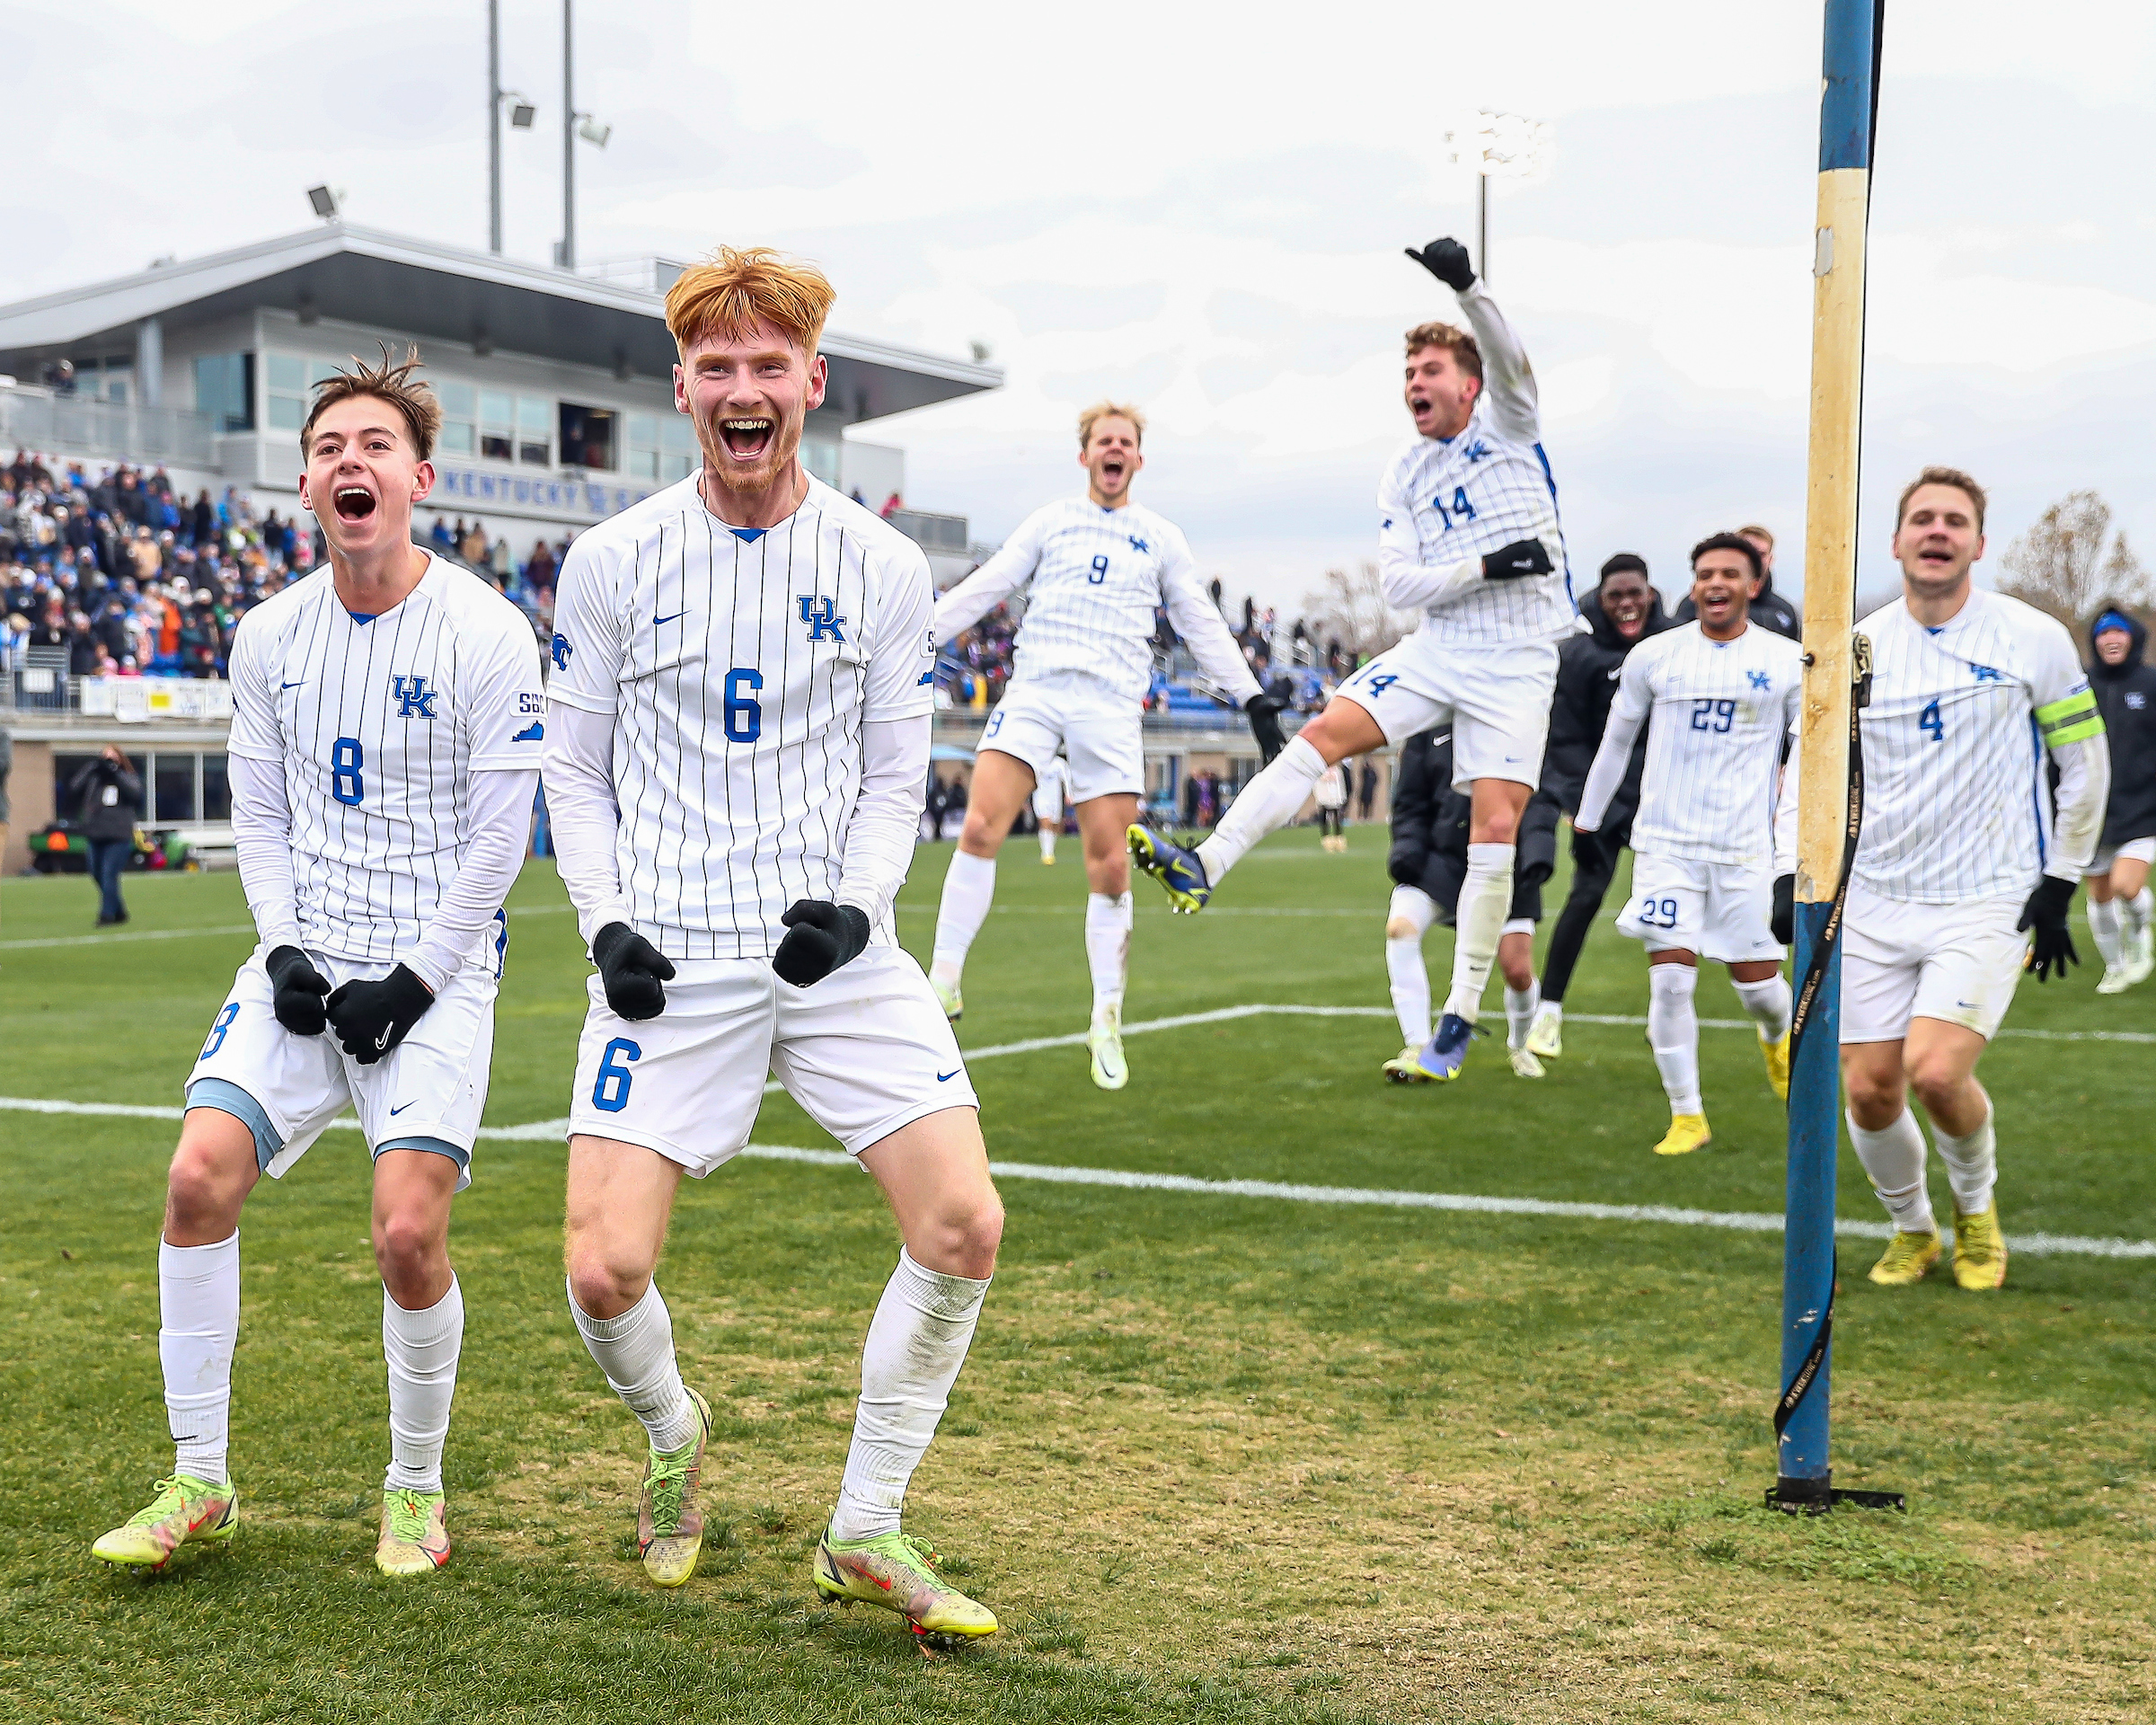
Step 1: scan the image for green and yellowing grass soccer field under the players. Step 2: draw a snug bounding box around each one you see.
[0,828,2156,1725]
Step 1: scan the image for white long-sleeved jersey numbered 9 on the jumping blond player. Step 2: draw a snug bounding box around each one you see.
[936,498,1257,705]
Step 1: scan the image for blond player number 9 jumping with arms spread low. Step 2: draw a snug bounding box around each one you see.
[929,401,1287,1091]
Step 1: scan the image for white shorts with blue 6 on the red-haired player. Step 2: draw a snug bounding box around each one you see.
[570,947,981,1180]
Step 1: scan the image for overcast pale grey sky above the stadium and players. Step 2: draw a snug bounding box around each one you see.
[0,0,2156,606]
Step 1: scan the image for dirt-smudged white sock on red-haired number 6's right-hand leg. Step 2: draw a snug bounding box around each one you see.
[830,1246,987,1540]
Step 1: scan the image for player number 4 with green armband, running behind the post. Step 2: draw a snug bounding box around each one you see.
[1774,468,2111,1289]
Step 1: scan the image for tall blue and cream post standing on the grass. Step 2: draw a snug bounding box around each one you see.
[1768,0,1886,1511]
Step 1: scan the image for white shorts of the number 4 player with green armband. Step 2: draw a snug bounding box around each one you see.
[1842,880,2028,1041]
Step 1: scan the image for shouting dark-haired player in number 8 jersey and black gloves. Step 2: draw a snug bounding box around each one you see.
[91,351,541,1576]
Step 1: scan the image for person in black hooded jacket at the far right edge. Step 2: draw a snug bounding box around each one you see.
[2087,602,2156,994]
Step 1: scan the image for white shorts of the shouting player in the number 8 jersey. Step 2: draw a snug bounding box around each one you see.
[185,923,507,1192]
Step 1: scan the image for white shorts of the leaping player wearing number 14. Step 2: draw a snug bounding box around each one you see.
[1335,634,1557,789]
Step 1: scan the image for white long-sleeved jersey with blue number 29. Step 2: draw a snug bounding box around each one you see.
[1580,621,1805,867]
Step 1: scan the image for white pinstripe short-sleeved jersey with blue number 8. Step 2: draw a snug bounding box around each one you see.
[228,554,543,960]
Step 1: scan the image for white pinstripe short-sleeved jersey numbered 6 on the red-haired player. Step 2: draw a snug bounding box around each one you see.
[548,474,936,960]
